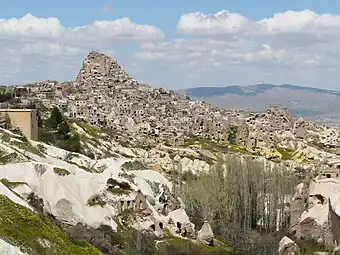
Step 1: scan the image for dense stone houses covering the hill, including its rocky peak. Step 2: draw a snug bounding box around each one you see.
[0,52,337,155]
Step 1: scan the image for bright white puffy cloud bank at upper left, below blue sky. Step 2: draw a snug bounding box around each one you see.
[0,14,164,41]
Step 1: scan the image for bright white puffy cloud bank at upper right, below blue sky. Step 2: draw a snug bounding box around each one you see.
[177,10,340,37]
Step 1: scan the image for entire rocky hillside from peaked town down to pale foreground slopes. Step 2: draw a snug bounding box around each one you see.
[0,52,340,255]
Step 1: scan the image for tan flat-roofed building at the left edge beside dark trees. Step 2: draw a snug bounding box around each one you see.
[0,109,38,140]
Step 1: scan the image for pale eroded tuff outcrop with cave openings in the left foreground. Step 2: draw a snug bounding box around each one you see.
[0,126,218,254]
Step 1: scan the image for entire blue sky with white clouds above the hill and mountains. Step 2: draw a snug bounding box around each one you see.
[0,0,340,90]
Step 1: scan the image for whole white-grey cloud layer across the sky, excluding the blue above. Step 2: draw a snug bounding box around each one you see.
[0,10,340,88]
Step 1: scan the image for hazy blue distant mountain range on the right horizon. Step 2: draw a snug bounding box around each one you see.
[179,84,340,124]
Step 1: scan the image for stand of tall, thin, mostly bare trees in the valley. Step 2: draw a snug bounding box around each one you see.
[179,154,298,255]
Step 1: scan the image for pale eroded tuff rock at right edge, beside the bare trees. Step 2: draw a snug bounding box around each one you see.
[290,167,340,248]
